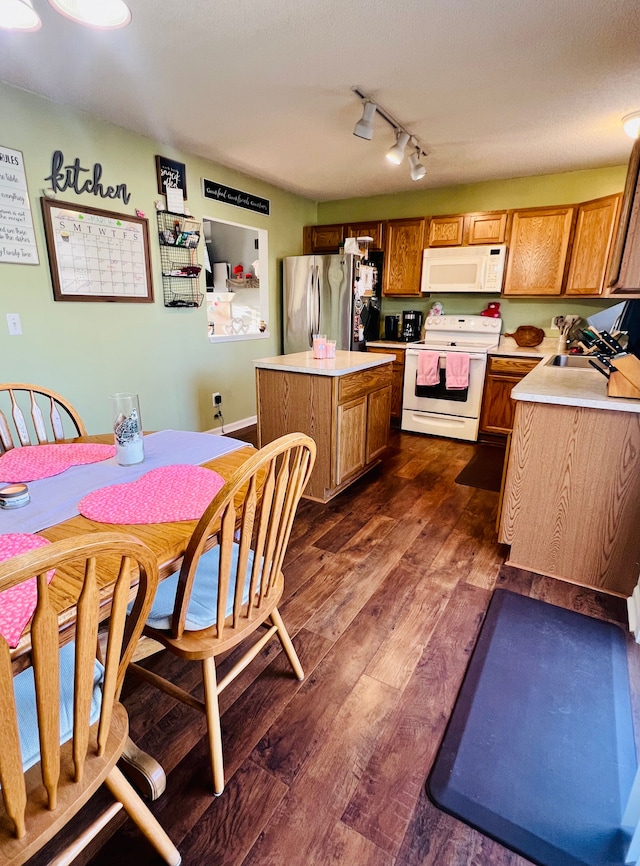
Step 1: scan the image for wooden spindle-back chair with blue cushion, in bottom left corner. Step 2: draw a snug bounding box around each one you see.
[0,532,180,866]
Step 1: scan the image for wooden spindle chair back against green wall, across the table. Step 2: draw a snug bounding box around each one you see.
[0,382,87,454]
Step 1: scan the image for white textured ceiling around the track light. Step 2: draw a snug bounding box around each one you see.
[0,0,640,201]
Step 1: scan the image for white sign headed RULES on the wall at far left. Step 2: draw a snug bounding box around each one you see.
[0,145,39,265]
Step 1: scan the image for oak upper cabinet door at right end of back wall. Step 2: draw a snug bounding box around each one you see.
[565,193,622,295]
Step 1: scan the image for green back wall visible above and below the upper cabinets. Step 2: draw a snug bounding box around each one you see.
[317,165,627,333]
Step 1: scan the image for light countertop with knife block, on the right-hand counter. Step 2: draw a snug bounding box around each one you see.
[511,352,640,413]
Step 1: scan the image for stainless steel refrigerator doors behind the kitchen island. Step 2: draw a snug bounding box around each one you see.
[282,255,353,354]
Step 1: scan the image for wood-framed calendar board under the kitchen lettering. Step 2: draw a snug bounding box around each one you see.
[41,198,153,303]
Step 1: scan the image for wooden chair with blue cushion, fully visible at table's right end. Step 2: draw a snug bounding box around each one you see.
[130,433,316,795]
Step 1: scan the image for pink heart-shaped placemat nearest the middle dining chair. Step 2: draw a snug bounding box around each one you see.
[78,464,224,523]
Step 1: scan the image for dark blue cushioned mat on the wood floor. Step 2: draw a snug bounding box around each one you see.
[427,589,636,866]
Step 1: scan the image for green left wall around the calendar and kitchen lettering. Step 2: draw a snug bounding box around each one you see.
[0,84,316,433]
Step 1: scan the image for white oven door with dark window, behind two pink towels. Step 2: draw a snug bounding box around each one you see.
[402,346,487,418]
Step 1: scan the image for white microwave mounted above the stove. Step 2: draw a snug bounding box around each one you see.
[420,244,507,294]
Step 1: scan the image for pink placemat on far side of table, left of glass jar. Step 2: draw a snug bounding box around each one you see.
[0,442,116,482]
